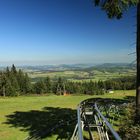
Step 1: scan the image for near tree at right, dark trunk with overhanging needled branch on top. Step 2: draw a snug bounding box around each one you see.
[93,0,140,121]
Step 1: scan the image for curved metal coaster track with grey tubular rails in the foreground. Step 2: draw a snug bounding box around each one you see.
[71,99,121,140]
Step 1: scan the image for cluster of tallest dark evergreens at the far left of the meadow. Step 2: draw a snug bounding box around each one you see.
[0,65,32,96]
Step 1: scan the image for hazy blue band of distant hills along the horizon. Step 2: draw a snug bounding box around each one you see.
[0,63,136,71]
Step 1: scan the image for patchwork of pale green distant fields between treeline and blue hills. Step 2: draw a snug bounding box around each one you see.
[28,69,135,82]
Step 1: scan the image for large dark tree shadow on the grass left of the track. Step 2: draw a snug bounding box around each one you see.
[6,107,76,139]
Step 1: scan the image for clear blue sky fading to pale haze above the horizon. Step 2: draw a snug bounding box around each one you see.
[0,0,136,65]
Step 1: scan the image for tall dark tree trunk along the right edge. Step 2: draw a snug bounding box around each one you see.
[136,2,140,121]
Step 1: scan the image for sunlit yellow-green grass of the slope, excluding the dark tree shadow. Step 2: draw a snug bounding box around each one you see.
[0,91,134,140]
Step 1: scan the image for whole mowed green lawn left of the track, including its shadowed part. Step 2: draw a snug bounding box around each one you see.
[0,90,135,140]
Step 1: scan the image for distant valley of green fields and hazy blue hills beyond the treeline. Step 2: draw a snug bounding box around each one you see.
[5,63,136,82]
